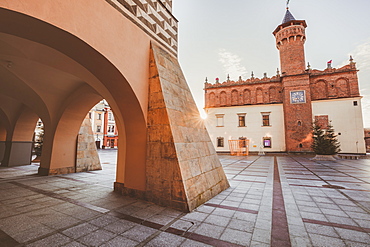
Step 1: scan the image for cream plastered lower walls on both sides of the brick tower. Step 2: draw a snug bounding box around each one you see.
[205,97,366,154]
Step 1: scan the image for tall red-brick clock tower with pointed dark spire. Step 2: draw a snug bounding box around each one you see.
[273,8,312,152]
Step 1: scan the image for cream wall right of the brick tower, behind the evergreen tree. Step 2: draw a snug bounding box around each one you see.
[312,97,366,153]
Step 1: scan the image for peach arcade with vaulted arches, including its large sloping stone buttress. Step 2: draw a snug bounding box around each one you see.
[0,0,229,211]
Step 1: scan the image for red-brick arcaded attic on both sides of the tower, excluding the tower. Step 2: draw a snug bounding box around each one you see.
[204,65,360,108]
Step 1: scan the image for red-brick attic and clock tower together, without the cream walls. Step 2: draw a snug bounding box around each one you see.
[204,10,360,152]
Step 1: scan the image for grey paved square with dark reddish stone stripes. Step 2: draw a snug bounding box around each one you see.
[0,150,370,247]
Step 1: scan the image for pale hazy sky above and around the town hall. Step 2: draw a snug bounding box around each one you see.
[173,0,370,128]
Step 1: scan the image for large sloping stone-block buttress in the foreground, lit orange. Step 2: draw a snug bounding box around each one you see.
[146,44,229,211]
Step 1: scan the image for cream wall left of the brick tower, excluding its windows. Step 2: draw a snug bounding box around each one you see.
[205,104,285,152]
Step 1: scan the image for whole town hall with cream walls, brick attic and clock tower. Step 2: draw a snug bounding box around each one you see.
[204,9,366,154]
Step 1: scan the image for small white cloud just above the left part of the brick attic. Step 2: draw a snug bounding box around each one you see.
[218,49,247,80]
